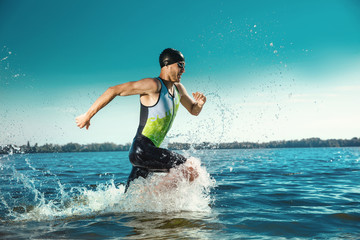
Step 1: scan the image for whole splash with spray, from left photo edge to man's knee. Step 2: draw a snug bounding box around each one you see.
[0,158,215,221]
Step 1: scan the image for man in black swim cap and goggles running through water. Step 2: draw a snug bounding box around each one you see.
[76,48,206,189]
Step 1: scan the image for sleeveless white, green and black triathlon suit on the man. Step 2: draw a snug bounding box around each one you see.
[126,78,186,189]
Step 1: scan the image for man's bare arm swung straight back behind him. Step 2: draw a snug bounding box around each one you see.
[76,78,159,129]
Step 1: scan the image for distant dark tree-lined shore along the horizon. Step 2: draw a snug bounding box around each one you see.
[0,137,360,154]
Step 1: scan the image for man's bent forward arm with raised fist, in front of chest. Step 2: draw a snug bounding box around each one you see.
[176,83,206,116]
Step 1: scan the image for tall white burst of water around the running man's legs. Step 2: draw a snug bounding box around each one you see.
[124,158,215,212]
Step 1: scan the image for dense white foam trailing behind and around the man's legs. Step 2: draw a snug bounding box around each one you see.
[12,158,215,221]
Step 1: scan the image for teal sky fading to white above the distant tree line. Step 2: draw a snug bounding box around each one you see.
[0,0,360,144]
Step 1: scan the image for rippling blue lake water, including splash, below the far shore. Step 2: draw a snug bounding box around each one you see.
[0,148,360,239]
